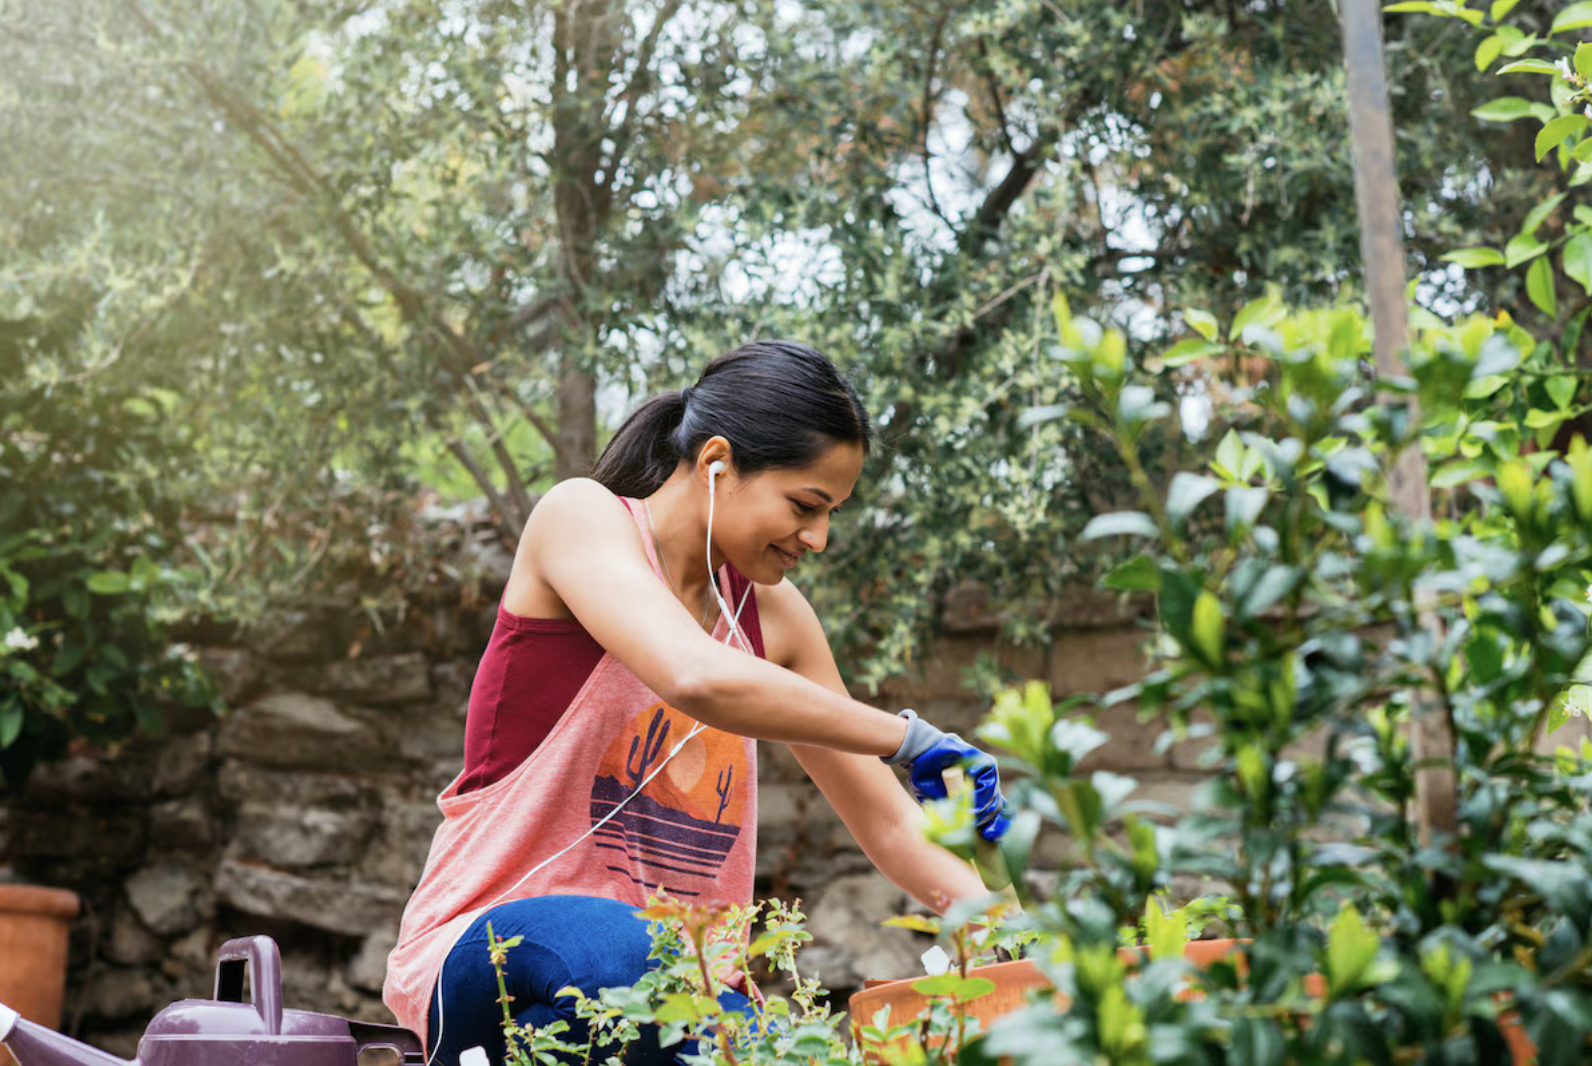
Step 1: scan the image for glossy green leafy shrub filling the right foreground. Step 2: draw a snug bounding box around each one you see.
[955,294,1592,1064]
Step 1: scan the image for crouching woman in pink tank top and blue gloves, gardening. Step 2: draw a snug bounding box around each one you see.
[385,342,1006,1066]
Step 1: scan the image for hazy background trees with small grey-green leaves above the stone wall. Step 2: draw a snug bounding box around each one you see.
[0,0,1553,683]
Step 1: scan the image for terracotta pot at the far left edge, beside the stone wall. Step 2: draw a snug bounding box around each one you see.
[0,885,78,1066]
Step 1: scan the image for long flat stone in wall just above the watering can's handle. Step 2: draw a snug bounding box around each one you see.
[215,859,409,937]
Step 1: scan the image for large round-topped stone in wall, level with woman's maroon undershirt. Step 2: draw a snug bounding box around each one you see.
[217,692,380,770]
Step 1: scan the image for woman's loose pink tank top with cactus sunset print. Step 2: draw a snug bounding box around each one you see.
[382,500,758,1039]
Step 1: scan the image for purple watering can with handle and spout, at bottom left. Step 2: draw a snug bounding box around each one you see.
[0,937,425,1066]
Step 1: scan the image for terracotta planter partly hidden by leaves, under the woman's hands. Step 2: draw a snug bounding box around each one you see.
[850,940,1536,1066]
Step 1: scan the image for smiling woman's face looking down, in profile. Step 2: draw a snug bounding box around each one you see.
[713,444,863,586]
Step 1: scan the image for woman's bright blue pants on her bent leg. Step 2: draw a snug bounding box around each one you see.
[427,896,751,1066]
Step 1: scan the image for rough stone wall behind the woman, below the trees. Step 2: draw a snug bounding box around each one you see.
[3,566,1171,1056]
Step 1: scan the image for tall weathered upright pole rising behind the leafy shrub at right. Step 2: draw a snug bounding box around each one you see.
[1340,0,1458,842]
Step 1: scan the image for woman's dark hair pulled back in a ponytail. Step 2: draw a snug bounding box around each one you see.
[592,340,872,496]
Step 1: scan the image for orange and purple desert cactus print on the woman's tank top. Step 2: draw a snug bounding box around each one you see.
[591,703,750,897]
